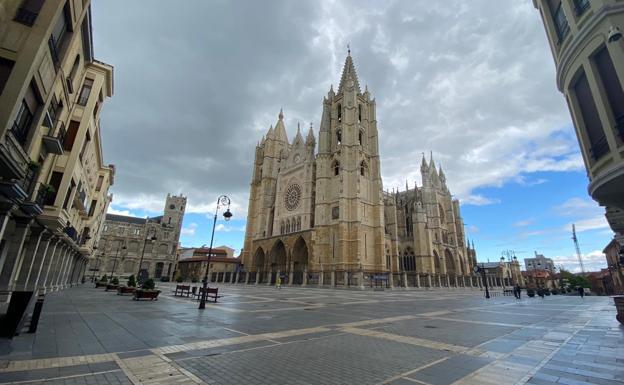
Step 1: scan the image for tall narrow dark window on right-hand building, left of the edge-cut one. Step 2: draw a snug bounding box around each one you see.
[573,72,609,160]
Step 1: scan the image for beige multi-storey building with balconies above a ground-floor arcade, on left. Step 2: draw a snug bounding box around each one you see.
[0,0,115,330]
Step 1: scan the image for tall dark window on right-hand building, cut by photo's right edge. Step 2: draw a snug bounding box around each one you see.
[594,46,624,140]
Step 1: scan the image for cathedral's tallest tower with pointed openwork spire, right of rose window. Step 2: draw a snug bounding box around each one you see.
[313,52,387,272]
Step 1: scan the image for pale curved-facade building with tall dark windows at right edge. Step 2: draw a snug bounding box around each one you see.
[533,0,624,234]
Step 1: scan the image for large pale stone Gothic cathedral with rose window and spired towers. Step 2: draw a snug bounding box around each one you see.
[242,52,478,287]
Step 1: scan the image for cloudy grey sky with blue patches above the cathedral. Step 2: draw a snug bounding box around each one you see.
[93,0,611,270]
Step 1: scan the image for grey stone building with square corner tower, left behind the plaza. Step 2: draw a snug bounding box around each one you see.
[89,195,186,279]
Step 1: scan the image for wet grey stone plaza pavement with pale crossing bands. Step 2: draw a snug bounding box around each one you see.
[0,284,624,385]
